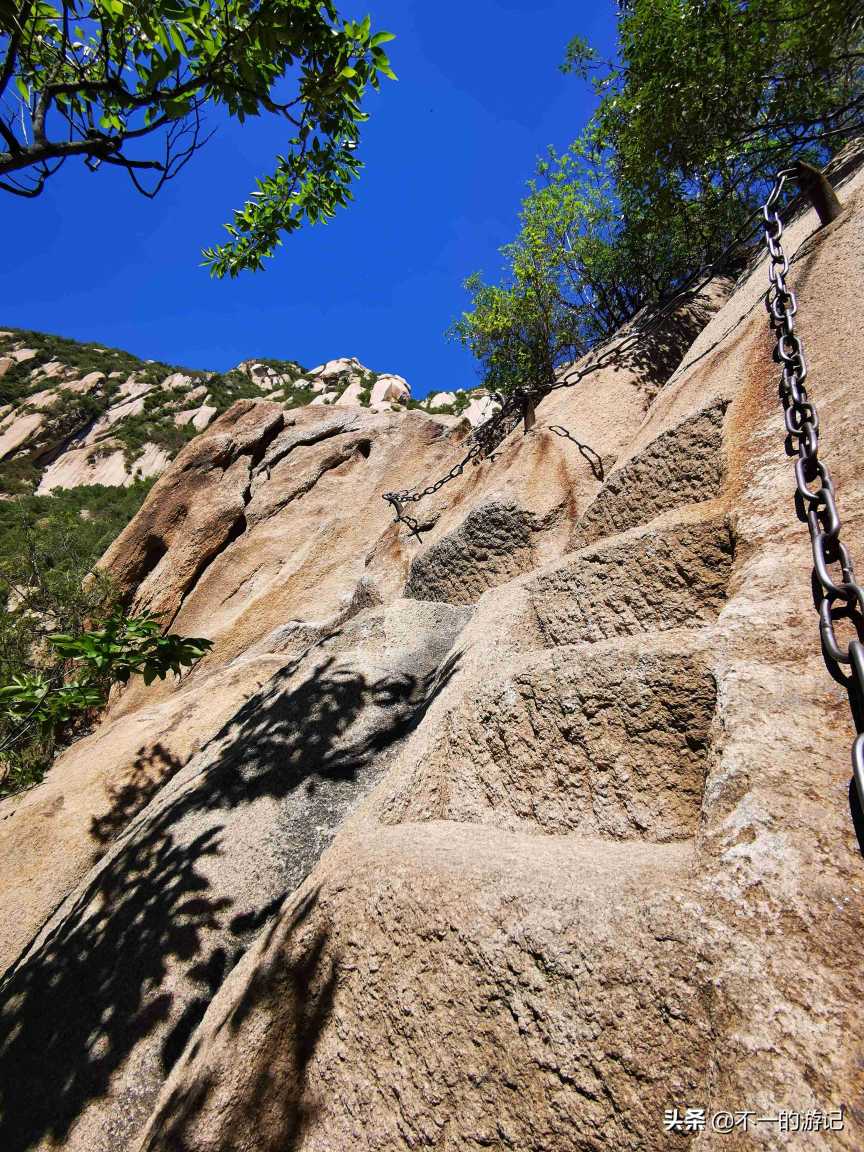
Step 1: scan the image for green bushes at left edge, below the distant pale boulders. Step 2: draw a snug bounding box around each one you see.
[0,484,211,796]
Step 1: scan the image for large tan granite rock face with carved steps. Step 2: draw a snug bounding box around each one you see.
[0,164,864,1152]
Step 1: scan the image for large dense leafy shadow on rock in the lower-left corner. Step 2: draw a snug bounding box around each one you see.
[0,797,226,1152]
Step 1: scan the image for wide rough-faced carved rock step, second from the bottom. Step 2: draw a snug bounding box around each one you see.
[381,631,717,842]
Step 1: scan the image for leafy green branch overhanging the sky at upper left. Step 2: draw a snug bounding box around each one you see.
[0,0,395,276]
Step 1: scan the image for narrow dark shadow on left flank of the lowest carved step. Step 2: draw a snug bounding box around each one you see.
[144,889,339,1152]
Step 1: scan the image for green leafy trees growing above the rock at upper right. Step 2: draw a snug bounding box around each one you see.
[453,0,864,391]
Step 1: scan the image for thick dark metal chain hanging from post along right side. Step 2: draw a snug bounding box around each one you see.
[763,168,864,805]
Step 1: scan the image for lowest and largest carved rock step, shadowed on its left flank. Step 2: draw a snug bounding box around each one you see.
[138,824,711,1152]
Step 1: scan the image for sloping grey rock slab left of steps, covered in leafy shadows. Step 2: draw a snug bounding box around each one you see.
[0,659,456,1152]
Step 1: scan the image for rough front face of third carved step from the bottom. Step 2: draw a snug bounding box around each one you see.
[529,506,734,647]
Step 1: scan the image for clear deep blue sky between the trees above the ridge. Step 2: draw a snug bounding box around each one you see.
[0,0,615,397]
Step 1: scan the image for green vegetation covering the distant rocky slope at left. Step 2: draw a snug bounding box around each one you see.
[0,329,426,795]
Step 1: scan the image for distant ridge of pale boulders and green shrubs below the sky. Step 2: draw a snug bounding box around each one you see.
[0,331,429,495]
